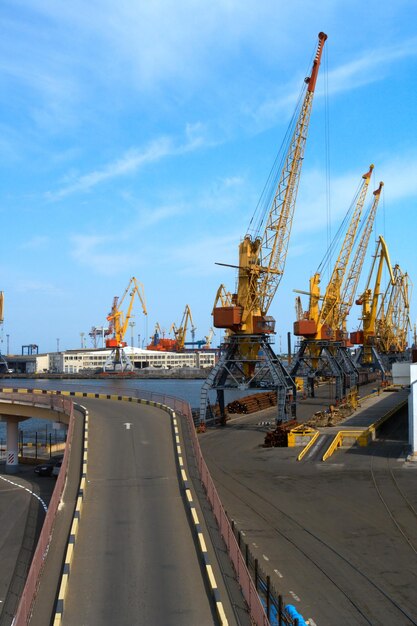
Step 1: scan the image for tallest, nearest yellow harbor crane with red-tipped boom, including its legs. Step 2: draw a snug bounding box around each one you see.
[200,33,327,423]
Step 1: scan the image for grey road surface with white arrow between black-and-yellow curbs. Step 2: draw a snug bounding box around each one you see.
[63,400,221,626]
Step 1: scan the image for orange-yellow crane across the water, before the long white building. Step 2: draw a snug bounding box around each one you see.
[104,276,147,371]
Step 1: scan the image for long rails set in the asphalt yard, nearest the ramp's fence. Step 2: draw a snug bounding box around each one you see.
[211,462,417,626]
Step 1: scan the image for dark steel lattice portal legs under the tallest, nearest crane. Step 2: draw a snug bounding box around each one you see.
[200,334,296,424]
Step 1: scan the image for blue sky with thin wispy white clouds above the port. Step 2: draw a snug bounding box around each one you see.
[0,0,417,353]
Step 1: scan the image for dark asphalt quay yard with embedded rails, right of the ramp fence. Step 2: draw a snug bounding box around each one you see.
[200,400,417,626]
